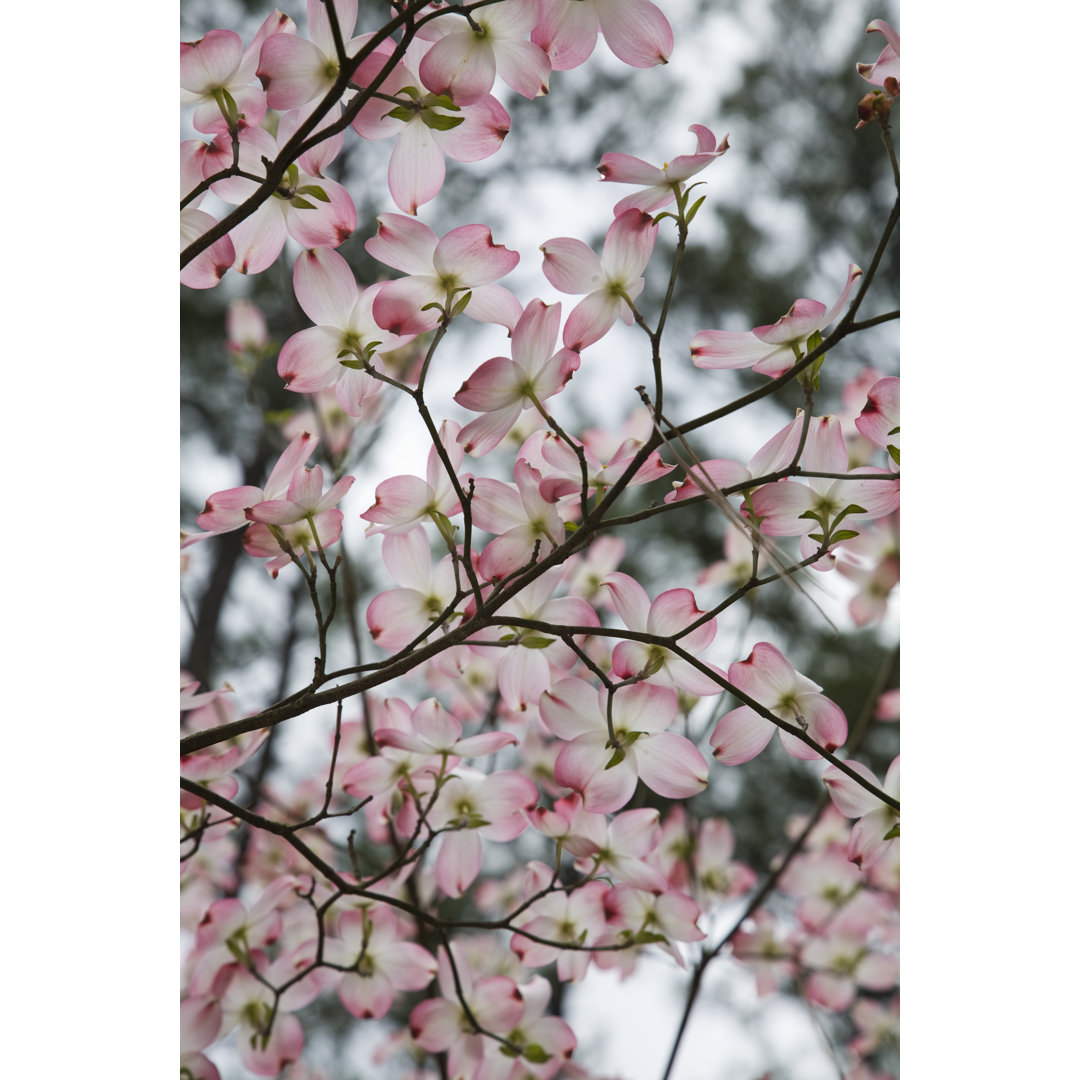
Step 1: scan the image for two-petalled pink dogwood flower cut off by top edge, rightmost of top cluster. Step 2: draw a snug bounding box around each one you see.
[532,0,674,71]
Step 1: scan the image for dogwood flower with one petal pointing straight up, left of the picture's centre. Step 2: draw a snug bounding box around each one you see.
[454,300,581,457]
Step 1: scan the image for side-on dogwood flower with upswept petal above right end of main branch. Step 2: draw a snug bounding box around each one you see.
[690,262,862,379]
